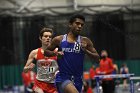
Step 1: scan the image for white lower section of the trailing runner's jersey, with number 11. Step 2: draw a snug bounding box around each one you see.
[36,59,58,83]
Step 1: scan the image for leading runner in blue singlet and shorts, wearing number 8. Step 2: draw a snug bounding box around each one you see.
[44,15,99,93]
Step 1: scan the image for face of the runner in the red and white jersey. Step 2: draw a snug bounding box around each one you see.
[41,32,52,45]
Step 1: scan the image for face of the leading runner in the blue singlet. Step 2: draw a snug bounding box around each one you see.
[70,18,84,35]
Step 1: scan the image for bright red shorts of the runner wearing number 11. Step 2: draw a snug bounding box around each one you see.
[33,80,57,93]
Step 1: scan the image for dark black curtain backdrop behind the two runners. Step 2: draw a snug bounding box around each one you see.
[0,12,140,65]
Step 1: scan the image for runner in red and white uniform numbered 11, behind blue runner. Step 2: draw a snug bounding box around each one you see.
[24,28,58,93]
